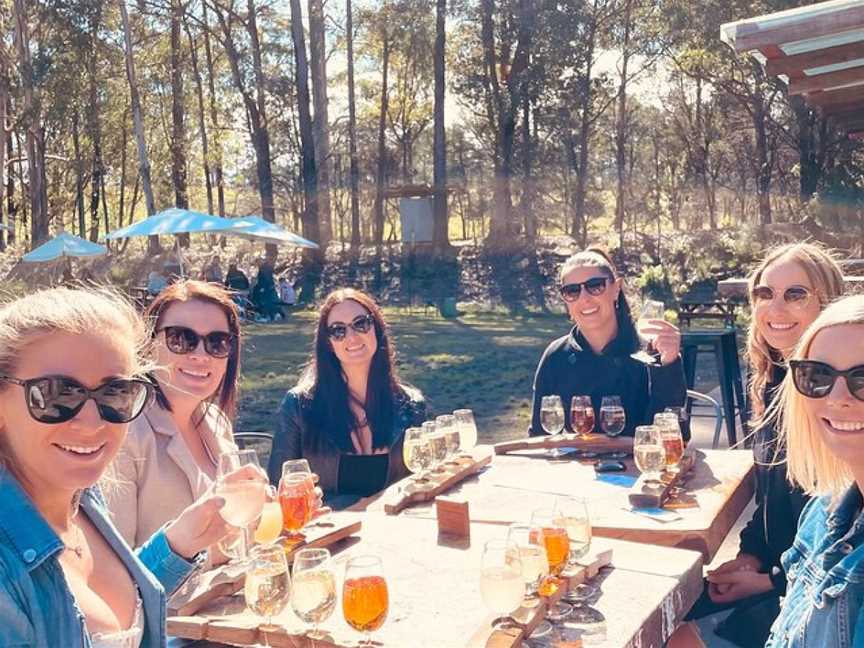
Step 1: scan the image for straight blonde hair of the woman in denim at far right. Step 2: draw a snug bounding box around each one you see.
[767,295,864,499]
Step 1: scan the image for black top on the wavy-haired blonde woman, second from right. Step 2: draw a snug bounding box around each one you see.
[741,366,810,594]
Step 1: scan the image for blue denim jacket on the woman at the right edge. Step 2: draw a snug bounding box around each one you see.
[765,484,864,648]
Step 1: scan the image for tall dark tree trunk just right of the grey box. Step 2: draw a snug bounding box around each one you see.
[432,0,450,251]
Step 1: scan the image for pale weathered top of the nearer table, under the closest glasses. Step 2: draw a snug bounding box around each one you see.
[172,512,702,648]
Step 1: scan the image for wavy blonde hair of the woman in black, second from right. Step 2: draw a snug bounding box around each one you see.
[747,243,843,416]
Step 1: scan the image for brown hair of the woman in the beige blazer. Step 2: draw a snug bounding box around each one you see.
[144,279,240,421]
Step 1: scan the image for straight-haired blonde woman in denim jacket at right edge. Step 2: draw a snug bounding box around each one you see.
[766,296,864,648]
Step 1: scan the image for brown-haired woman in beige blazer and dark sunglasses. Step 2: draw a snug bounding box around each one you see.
[109,281,240,547]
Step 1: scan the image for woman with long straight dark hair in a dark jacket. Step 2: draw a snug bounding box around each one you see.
[268,288,426,506]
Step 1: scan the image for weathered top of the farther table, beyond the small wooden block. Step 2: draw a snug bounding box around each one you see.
[352,450,753,562]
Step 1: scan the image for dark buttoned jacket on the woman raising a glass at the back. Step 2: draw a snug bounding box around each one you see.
[529,327,690,440]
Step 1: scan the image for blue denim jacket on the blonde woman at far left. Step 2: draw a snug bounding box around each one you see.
[0,469,193,648]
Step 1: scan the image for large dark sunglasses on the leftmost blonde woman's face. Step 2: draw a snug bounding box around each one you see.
[0,376,153,424]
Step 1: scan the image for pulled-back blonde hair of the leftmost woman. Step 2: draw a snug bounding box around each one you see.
[0,288,150,473]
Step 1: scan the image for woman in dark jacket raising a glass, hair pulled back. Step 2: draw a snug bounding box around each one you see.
[529,248,687,438]
